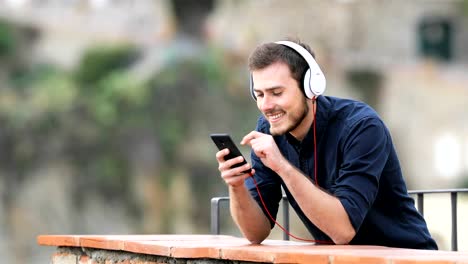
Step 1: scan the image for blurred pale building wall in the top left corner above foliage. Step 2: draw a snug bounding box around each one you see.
[0,0,175,66]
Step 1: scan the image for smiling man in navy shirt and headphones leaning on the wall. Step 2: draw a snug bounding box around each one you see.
[216,41,437,249]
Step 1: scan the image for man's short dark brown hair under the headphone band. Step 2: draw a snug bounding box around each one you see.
[249,39,315,88]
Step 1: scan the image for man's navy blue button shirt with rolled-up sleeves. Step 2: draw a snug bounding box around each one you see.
[246,96,437,249]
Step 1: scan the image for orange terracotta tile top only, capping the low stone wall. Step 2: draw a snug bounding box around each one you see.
[37,235,468,264]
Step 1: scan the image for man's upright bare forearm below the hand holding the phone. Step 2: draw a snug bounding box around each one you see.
[229,185,271,244]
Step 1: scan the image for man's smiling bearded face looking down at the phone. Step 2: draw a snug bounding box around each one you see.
[252,62,309,135]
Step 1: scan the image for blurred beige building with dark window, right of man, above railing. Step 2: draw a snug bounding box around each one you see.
[209,0,468,188]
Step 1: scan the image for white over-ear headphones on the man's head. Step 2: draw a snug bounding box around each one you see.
[250,41,326,100]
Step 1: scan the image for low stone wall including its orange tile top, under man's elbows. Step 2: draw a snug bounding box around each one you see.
[38,235,468,264]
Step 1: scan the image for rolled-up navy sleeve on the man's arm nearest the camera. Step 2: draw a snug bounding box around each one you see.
[333,118,391,231]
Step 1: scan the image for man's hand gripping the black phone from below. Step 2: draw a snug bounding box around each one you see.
[216,148,255,187]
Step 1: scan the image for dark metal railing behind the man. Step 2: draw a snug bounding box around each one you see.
[210,189,468,251]
